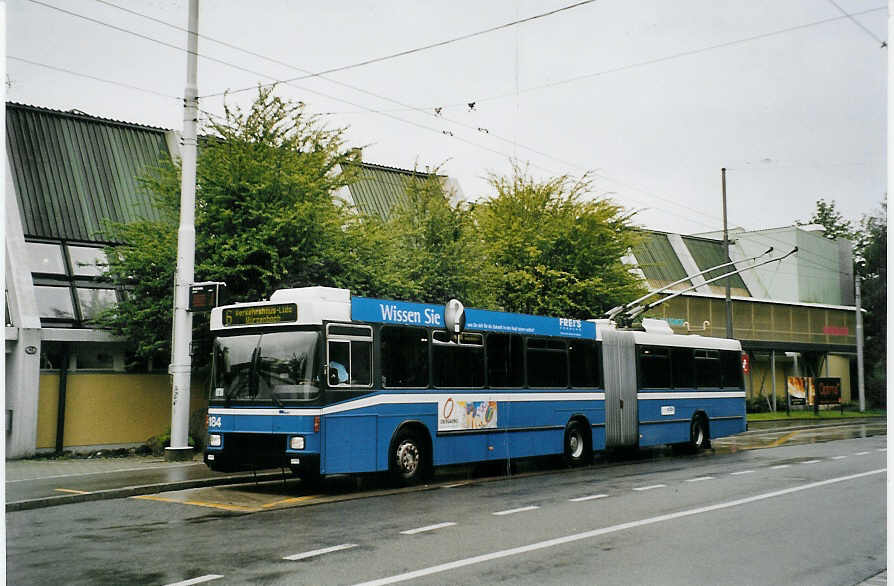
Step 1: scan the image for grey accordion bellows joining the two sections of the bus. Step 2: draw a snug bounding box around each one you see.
[602,330,639,448]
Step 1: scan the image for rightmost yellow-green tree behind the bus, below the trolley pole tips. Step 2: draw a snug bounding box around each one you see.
[476,166,644,318]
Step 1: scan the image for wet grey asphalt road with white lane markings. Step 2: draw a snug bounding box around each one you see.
[7,426,886,584]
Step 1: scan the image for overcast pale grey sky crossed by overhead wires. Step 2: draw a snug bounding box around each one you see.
[7,0,888,233]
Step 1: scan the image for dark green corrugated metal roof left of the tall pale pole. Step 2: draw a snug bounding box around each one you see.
[6,103,170,242]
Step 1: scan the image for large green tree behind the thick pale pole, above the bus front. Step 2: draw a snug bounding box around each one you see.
[103,88,355,359]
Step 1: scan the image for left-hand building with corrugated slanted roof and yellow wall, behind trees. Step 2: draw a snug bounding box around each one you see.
[5,103,461,458]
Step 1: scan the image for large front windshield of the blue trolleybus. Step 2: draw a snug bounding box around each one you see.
[211,331,320,404]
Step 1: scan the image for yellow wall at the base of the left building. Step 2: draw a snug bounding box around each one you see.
[37,373,208,449]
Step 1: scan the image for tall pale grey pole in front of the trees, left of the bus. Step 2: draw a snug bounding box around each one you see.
[165,0,199,461]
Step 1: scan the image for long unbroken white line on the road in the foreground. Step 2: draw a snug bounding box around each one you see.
[356,468,887,586]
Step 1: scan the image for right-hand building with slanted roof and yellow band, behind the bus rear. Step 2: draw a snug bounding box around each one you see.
[625,226,856,408]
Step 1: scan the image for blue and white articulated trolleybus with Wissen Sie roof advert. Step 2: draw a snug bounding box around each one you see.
[205,287,745,484]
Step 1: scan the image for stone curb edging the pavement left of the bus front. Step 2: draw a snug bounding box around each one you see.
[6,472,282,513]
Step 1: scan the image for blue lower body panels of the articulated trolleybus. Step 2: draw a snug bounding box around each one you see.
[208,391,745,474]
